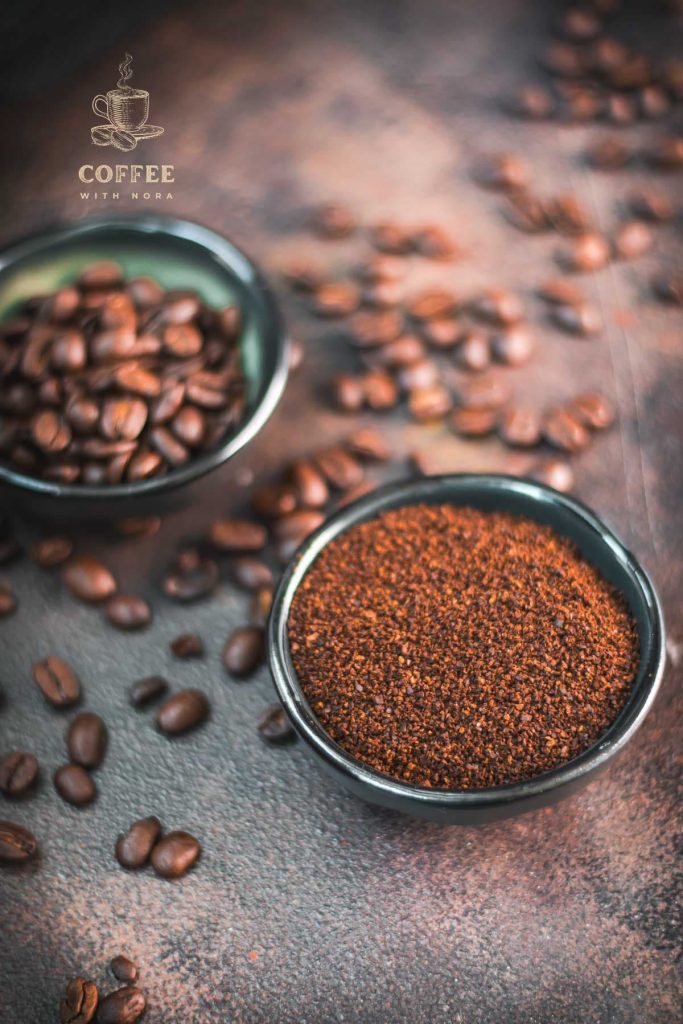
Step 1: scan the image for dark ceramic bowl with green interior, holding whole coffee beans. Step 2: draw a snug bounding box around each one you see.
[0,215,289,519]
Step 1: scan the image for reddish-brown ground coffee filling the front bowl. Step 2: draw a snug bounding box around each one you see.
[289,505,639,790]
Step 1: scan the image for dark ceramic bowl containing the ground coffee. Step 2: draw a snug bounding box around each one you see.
[268,475,665,824]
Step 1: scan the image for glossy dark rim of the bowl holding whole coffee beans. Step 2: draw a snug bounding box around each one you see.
[0,213,291,503]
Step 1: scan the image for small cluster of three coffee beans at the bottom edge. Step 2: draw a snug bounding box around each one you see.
[59,953,147,1024]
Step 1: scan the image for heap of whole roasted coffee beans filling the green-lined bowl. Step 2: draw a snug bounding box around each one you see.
[0,261,246,487]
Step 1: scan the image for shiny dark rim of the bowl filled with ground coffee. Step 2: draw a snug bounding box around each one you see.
[268,473,666,810]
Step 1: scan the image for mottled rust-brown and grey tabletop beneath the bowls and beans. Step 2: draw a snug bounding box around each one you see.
[0,0,683,1024]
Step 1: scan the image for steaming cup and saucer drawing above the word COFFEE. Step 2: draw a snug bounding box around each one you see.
[90,53,164,153]
